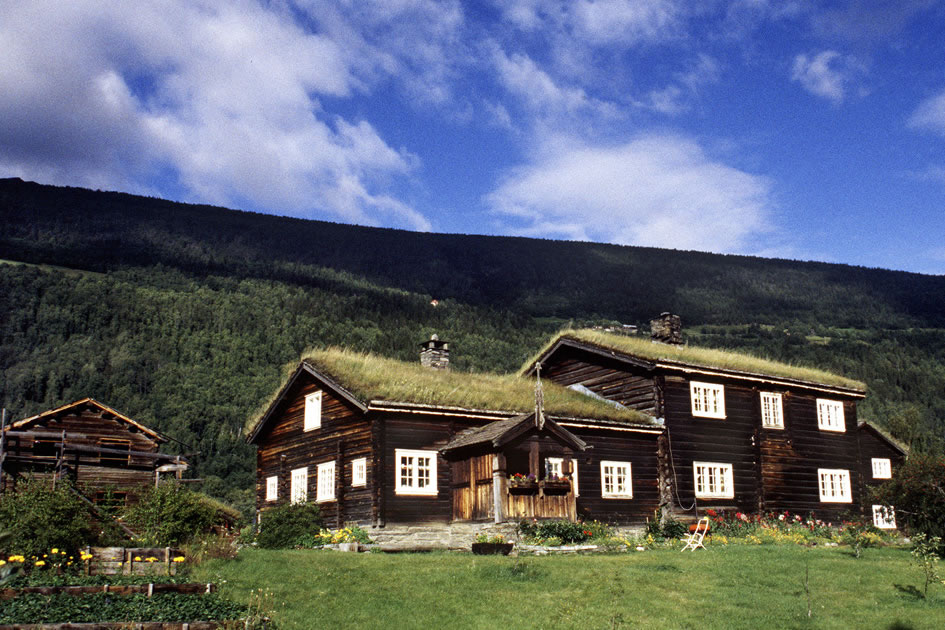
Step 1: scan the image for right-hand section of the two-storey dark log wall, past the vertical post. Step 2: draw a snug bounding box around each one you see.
[764,396,861,522]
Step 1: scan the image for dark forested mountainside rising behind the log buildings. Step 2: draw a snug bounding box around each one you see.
[0,180,945,520]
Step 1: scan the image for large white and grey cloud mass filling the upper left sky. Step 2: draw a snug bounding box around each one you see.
[0,0,430,229]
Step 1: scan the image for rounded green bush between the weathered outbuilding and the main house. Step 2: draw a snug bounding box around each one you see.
[125,481,216,547]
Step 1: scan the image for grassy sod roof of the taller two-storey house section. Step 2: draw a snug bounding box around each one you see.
[519,329,866,391]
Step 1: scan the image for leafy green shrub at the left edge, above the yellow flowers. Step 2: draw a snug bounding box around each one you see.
[0,479,94,557]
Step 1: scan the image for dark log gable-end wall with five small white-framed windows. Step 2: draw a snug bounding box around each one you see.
[256,379,375,527]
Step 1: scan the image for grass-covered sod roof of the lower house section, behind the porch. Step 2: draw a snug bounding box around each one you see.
[247,348,653,440]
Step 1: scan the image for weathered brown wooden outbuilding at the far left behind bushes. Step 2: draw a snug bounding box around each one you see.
[0,398,187,503]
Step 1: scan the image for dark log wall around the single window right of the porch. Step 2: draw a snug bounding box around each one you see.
[565,426,660,525]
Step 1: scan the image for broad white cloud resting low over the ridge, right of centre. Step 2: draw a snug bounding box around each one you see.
[486,136,773,253]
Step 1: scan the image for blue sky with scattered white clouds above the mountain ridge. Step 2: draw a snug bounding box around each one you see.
[0,0,945,274]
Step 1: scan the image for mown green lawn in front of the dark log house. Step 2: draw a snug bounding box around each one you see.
[197,546,945,630]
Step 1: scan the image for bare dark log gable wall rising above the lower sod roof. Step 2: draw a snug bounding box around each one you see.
[543,348,659,416]
